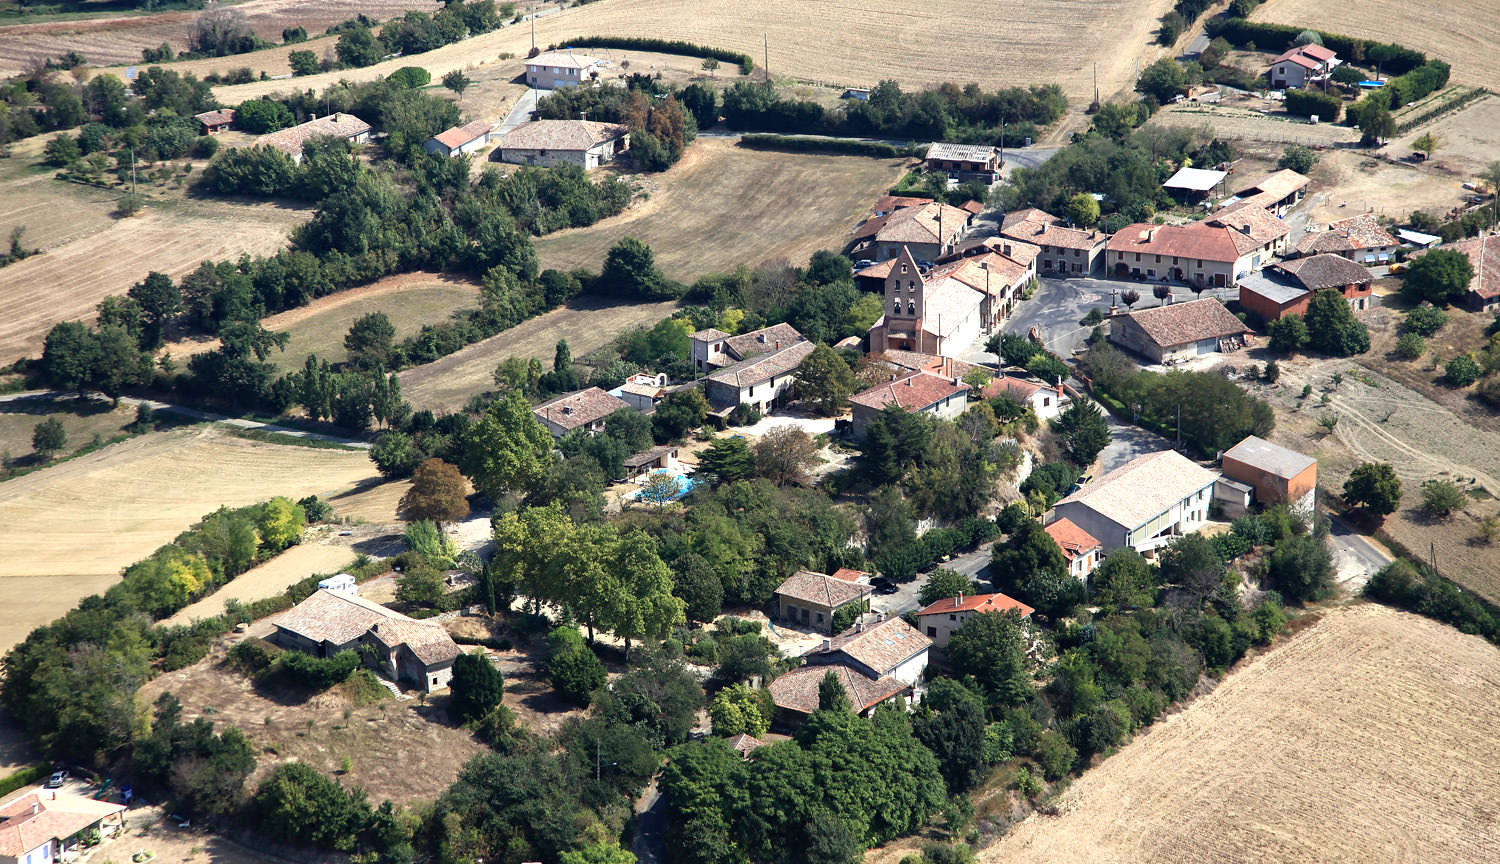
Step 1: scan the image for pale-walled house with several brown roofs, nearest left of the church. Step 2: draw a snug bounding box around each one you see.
[690,324,816,416]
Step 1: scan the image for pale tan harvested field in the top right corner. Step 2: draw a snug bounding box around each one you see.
[1250,0,1500,90]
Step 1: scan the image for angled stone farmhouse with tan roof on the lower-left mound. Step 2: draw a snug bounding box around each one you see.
[272,590,459,693]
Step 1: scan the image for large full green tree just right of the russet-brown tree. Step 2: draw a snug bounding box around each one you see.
[459,390,555,500]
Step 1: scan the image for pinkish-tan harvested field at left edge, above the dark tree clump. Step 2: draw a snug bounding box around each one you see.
[0,203,311,365]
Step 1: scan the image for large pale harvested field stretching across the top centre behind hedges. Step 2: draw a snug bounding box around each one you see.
[183,0,1172,105]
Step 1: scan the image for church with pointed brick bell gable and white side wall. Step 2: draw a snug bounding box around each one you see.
[870,249,990,356]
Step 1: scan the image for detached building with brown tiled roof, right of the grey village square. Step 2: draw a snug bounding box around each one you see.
[1110,297,1253,365]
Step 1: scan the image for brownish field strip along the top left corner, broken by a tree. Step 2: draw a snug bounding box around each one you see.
[0,0,441,75]
